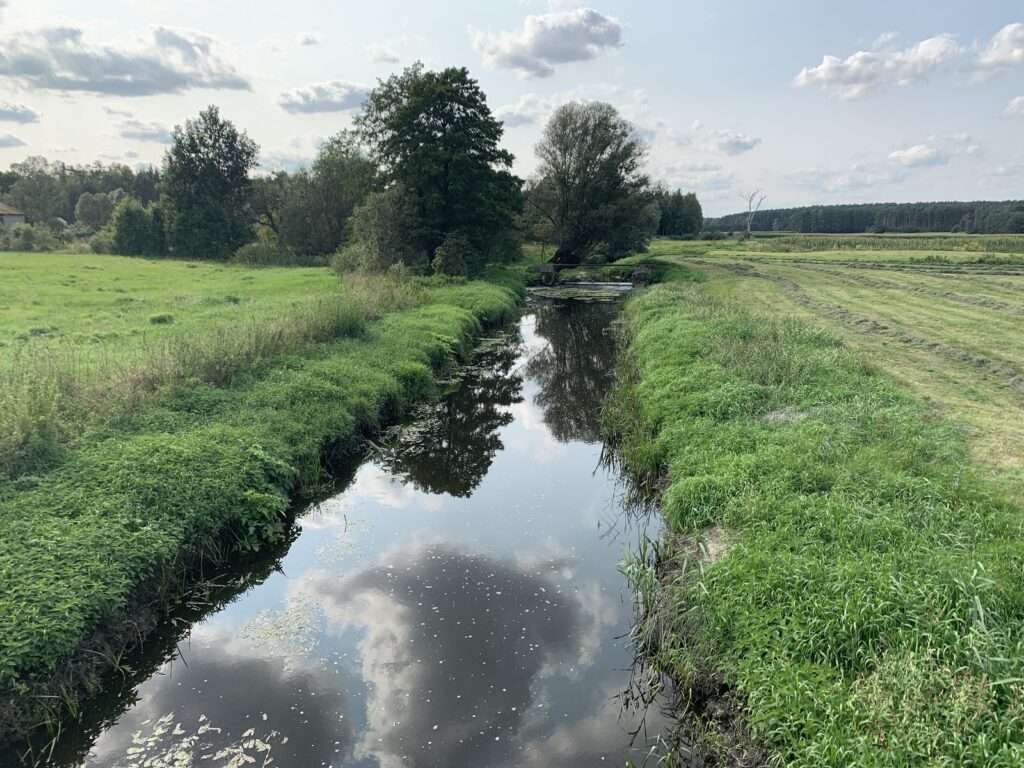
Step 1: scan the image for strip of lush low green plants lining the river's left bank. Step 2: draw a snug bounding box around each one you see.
[0,275,521,741]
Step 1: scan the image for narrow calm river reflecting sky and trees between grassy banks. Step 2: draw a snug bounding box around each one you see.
[32,300,658,768]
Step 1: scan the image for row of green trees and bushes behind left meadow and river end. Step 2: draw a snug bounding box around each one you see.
[0,63,703,274]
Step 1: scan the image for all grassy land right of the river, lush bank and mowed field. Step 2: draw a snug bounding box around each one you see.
[606,238,1024,766]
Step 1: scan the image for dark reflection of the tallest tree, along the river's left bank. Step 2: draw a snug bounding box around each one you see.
[380,331,522,497]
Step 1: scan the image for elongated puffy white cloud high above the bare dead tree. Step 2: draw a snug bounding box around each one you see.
[794,35,964,99]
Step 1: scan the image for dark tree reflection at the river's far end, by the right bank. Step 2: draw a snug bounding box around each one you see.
[526,302,617,442]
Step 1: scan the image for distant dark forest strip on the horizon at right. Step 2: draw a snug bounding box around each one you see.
[705,200,1024,234]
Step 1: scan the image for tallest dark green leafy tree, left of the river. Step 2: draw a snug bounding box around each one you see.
[356,63,522,271]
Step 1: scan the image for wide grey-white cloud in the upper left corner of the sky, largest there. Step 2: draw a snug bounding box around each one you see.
[0,27,250,96]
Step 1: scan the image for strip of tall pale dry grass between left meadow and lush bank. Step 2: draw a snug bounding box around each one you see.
[0,274,429,479]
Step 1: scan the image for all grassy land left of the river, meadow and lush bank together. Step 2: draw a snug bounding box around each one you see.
[0,254,521,740]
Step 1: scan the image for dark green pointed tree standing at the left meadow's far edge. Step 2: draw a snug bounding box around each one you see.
[161,106,259,259]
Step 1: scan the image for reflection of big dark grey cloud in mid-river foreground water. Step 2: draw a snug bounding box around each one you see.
[301,543,607,767]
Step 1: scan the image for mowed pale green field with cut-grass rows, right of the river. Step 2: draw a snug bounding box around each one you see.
[652,236,1024,499]
